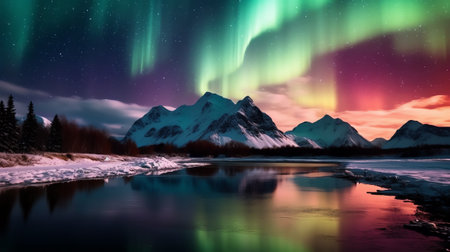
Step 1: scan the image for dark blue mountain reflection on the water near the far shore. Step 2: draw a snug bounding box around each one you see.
[132,163,342,195]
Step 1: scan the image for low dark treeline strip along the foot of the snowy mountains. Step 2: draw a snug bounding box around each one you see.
[139,140,450,157]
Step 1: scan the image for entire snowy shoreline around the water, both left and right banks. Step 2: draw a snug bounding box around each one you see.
[0,153,450,243]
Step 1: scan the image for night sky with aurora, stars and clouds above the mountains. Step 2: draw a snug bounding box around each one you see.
[0,0,450,140]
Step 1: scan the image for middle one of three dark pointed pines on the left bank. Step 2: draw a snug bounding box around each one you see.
[20,102,39,152]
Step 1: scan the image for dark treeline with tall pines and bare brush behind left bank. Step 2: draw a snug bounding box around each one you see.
[0,96,139,155]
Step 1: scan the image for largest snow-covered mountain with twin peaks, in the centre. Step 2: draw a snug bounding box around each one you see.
[125,92,297,148]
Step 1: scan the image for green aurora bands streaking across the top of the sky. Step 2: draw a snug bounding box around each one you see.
[0,0,450,109]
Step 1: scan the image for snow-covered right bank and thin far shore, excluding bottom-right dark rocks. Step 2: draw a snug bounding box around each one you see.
[203,157,450,210]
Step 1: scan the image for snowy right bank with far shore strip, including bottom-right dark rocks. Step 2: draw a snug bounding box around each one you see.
[203,157,450,245]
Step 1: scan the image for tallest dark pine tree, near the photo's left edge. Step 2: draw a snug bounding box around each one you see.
[4,95,19,152]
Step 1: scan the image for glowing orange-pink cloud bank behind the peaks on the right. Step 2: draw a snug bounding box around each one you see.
[252,85,450,140]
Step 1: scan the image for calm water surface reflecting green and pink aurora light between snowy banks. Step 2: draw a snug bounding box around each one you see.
[0,163,442,251]
